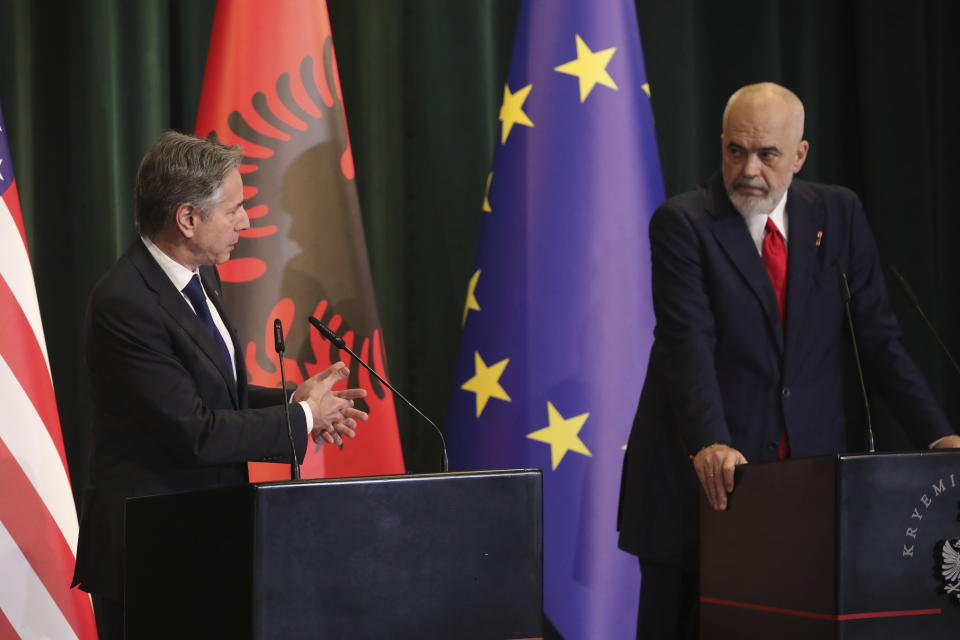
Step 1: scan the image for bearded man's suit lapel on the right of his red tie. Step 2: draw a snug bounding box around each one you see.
[786,181,824,358]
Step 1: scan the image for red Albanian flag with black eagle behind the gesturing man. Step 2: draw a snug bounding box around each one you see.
[196,0,404,479]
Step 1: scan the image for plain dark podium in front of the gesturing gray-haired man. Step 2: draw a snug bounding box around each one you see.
[126,470,543,640]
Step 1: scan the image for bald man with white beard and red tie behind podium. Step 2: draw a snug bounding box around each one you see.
[618,83,960,639]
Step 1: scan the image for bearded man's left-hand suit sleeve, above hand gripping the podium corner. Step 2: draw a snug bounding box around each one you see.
[650,206,731,455]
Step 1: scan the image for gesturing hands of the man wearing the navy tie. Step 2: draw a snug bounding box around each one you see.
[292,362,368,444]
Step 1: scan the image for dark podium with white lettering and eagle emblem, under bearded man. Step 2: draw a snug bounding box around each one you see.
[700,451,960,640]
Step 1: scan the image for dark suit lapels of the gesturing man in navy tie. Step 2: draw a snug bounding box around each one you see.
[128,240,240,408]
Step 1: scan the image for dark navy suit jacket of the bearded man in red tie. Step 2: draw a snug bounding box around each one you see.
[619,174,952,565]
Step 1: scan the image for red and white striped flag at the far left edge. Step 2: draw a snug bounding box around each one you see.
[0,106,97,639]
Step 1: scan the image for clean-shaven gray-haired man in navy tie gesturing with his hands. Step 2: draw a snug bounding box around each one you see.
[74,131,367,638]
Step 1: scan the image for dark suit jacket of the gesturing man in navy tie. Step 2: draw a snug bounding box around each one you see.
[74,239,307,599]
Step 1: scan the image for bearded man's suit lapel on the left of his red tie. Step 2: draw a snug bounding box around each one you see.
[710,177,792,353]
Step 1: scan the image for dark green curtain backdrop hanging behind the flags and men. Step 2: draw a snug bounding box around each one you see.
[0,0,960,500]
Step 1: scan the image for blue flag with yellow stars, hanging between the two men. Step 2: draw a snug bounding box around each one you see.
[447,0,664,638]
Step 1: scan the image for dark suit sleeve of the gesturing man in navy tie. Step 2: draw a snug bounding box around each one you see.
[87,284,307,466]
